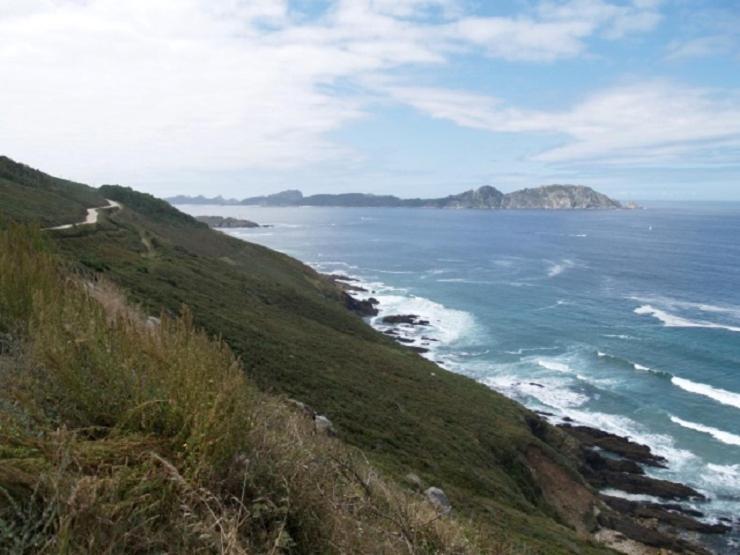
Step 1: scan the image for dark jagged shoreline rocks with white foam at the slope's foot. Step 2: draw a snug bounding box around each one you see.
[330,271,740,554]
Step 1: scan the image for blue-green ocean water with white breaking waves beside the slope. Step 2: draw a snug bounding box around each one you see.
[179,204,740,553]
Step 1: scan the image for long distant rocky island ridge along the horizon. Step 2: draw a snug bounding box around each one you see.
[167,185,624,210]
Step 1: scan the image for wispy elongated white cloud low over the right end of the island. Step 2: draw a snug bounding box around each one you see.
[386,81,740,163]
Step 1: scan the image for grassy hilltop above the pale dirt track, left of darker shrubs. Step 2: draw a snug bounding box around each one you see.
[0,156,105,227]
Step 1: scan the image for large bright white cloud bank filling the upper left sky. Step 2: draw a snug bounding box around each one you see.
[0,0,657,185]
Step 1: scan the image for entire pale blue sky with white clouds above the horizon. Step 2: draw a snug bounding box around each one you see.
[0,0,740,201]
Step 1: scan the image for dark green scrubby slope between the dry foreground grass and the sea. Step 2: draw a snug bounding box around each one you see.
[1,161,608,553]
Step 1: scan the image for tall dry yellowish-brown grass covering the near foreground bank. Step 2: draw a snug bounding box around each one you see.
[0,227,514,554]
